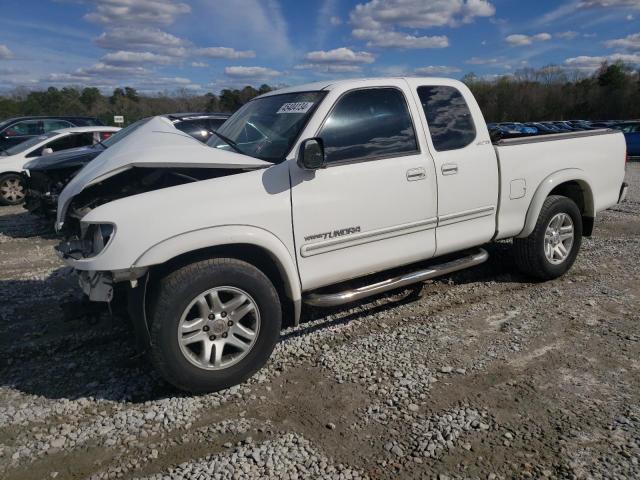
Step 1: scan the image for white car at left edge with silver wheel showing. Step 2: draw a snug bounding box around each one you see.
[0,126,120,205]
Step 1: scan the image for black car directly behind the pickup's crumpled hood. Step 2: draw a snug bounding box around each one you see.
[24,113,230,217]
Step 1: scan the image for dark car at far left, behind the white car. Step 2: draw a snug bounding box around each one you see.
[0,117,103,151]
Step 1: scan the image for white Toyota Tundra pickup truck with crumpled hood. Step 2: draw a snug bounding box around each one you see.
[56,78,626,392]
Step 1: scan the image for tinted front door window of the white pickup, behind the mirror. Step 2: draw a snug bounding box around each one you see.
[320,88,418,162]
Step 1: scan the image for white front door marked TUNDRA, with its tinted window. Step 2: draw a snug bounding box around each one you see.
[290,79,437,290]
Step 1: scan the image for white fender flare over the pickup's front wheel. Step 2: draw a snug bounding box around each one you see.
[131,225,302,325]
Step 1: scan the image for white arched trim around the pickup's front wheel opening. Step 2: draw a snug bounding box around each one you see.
[132,225,302,326]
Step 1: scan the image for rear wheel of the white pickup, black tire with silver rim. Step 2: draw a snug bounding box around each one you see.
[513,195,582,280]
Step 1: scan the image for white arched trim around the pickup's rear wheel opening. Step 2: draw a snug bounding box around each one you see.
[516,168,596,238]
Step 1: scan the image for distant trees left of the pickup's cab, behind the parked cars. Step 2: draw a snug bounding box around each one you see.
[0,85,272,125]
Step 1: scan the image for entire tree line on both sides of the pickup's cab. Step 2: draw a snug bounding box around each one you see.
[0,63,640,124]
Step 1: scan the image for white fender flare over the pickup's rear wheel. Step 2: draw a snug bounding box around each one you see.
[516,168,596,238]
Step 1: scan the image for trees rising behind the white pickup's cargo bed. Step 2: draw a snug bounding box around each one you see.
[462,63,640,122]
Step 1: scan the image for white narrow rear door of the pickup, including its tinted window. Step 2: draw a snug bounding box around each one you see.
[408,79,499,255]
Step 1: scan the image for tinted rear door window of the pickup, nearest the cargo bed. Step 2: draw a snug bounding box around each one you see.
[418,86,476,152]
